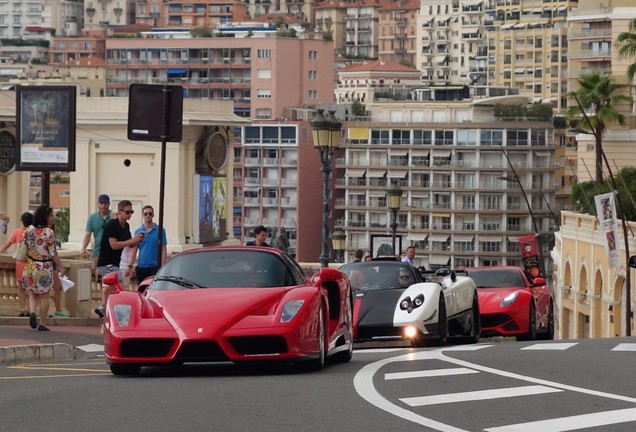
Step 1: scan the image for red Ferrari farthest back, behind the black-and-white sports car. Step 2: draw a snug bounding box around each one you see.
[466,266,554,340]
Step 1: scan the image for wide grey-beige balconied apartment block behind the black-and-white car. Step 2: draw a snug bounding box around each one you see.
[335,96,556,269]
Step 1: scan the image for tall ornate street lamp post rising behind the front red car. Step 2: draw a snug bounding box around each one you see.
[309,109,342,267]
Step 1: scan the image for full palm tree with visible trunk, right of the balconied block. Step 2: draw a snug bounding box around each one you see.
[567,71,632,183]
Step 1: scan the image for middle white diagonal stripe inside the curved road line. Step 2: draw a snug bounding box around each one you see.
[400,386,563,406]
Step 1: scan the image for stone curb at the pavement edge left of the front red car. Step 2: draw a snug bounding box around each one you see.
[0,343,99,365]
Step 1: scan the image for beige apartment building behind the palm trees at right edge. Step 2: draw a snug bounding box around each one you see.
[567,0,636,181]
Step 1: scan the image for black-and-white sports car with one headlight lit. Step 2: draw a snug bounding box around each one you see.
[340,260,480,346]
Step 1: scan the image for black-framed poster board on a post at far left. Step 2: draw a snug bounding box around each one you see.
[16,86,76,171]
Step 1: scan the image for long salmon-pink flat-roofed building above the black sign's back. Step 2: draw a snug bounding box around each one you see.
[106,35,334,120]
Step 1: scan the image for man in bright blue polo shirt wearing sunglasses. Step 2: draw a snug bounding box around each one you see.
[131,205,168,283]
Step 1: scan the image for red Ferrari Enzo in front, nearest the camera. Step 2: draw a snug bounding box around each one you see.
[104,246,353,375]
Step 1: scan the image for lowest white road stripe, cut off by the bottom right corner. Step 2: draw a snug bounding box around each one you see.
[486,408,636,432]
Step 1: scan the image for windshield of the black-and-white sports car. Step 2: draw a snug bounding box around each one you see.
[340,261,420,290]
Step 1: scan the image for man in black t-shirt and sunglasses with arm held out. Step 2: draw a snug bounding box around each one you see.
[95,200,143,318]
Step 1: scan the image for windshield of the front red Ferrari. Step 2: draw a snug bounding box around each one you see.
[151,248,303,290]
